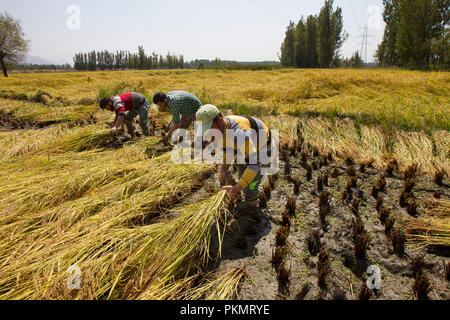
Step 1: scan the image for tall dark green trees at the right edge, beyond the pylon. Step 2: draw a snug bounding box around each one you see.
[376,0,450,69]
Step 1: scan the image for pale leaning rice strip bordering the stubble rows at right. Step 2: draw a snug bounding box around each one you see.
[301,117,450,176]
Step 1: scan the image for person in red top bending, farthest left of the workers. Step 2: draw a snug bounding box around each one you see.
[100,92,150,137]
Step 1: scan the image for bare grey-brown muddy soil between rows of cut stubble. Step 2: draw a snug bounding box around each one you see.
[211,150,450,300]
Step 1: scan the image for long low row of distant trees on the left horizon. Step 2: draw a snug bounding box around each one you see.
[73,46,185,71]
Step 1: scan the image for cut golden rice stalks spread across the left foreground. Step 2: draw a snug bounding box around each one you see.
[0,100,234,299]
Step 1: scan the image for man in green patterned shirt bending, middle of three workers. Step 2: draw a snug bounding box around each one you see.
[153,91,202,145]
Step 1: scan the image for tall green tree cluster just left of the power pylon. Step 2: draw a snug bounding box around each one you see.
[280,0,348,68]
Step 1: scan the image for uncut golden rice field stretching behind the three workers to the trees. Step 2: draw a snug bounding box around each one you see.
[0,69,450,175]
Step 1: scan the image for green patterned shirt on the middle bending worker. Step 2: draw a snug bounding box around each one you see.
[167,91,202,124]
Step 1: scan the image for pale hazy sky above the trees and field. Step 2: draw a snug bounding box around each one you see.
[0,0,384,63]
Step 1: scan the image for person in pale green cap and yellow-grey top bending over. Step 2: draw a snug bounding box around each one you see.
[196,105,272,208]
